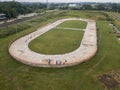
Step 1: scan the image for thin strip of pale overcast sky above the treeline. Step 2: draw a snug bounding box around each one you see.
[0,0,120,3]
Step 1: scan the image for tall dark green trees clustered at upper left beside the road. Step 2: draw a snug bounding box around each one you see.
[0,1,46,19]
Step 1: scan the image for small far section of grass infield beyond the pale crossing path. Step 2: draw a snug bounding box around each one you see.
[58,20,87,29]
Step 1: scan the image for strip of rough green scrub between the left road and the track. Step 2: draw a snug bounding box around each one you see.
[0,11,63,38]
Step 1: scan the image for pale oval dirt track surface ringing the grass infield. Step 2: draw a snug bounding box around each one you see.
[9,18,97,68]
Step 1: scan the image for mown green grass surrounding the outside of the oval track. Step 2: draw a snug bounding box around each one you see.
[0,11,120,90]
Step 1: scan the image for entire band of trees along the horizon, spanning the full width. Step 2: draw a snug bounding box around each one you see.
[0,1,120,19]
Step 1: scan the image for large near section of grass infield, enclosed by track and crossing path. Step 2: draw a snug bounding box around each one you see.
[29,29,84,54]
